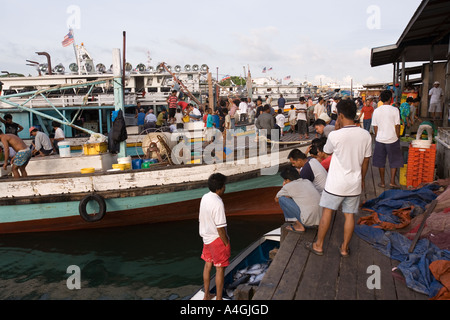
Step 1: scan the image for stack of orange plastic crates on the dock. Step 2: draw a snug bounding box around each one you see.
[406,144,436,188]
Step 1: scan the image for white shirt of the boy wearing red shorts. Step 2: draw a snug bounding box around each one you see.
[199,192,227,244]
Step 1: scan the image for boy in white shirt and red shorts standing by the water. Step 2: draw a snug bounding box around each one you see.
[199,173,231,300]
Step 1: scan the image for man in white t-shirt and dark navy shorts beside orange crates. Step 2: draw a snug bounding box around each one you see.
[372,90,404,188]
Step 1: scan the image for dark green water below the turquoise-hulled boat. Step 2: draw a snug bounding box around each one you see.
[0,215,283,300]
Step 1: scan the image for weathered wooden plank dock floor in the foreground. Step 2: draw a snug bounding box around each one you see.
[253,159,428,300]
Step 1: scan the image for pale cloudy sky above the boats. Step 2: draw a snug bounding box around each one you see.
[0,0,421,85]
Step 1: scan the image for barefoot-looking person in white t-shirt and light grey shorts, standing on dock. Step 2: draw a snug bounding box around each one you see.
[305,100,372,257]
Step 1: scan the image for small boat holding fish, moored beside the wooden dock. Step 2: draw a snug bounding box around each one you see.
[191,229,281,300]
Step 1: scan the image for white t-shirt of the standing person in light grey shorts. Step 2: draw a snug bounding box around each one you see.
[323,126,372,197]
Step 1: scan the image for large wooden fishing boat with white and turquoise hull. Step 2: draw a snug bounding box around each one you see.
[0,49,308,234]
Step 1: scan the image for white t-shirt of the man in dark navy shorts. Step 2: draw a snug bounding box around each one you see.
[372,105,400,144]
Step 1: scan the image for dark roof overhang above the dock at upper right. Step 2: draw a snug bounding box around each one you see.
[371,0,450,67]
